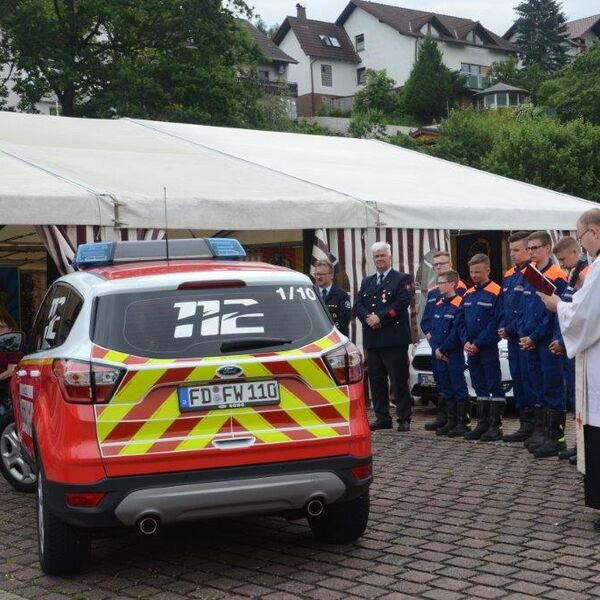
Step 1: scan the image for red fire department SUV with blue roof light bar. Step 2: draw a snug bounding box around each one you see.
[5,239,372,574]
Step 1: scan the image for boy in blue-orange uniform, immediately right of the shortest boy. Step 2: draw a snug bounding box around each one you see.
[458,254,506,442]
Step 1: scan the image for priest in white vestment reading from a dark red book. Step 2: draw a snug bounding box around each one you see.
[540,208,600,530]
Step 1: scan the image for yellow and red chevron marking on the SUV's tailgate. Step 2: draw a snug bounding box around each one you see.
[93,332,350,456]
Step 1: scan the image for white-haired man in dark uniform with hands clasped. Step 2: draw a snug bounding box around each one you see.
[356,242,414,431]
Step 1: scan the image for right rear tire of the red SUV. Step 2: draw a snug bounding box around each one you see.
[308,490,369,544]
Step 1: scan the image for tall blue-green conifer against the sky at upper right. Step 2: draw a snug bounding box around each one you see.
[515,0,568,73]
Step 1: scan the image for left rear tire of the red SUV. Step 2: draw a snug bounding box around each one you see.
[36,468,92,575]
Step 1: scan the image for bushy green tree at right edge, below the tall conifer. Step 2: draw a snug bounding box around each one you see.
[539,43,600,125]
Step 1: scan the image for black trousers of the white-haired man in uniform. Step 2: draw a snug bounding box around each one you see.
[367,345,412,423]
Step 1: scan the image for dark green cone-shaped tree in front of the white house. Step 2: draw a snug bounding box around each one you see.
[401,36,462,122]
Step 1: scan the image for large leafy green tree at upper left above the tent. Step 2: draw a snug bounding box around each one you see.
[0,0,270,126]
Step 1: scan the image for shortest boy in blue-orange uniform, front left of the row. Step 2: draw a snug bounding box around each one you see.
[429,271,470,437]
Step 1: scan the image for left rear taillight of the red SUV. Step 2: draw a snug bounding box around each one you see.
[52,358,125,404]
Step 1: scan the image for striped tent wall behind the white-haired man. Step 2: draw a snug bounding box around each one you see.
[313,227,450,344]
